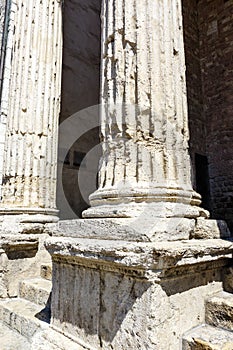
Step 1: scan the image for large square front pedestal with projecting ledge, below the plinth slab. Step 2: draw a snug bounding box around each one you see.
[46,237,233,350]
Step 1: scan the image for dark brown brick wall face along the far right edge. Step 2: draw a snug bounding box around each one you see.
[198,0,233,229]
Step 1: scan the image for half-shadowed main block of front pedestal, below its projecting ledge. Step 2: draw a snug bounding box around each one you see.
[49,259,224,350]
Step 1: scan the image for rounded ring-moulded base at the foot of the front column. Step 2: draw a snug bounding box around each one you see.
[82,188,206,219]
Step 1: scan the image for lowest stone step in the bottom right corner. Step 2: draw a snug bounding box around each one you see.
[182,325,233,350]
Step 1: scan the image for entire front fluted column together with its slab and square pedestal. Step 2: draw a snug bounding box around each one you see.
[45,0,233,350]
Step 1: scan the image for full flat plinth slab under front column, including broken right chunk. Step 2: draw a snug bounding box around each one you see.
[46,212,230,242]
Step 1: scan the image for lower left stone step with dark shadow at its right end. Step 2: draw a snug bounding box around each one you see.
[0,298,50,339]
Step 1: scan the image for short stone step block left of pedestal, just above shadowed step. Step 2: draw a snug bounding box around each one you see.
[19,277,52,306]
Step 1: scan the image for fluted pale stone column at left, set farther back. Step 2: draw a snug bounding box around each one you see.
[1,0,62,221]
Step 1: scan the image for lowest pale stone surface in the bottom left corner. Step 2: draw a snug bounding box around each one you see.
[0,322,31,350]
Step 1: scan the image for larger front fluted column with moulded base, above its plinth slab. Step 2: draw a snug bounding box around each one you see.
[84,0,200,217]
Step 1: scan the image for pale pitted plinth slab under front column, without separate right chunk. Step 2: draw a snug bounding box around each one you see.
[46,217,195,242]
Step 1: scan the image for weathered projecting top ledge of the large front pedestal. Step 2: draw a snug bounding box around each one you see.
[45,237,233,271]
